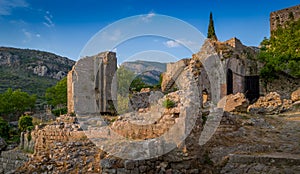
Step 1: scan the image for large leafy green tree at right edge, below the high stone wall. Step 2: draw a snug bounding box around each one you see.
[259,20,300,82]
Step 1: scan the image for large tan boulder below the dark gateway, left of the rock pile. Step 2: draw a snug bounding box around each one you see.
[224,93,249,112]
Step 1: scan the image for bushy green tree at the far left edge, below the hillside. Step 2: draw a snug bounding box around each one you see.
[0,88,36,119]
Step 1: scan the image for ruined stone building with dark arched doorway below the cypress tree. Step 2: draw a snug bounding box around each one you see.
[162,38,261,101]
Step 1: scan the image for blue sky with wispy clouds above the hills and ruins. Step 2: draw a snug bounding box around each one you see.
[0,0,299,60]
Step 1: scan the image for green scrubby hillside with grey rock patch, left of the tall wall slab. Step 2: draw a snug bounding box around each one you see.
[0,47,75,102]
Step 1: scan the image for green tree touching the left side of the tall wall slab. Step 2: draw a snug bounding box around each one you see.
[45,77,67,107]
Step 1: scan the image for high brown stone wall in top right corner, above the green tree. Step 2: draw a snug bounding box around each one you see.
[270,5,300,33]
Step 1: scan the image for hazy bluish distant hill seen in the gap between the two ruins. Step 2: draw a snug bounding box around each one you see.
[122,60,166,85]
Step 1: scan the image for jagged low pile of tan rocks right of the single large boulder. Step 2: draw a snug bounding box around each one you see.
[248,92,292,114]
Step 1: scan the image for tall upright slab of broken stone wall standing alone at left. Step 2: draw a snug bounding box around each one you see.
[68,52,117,114]
